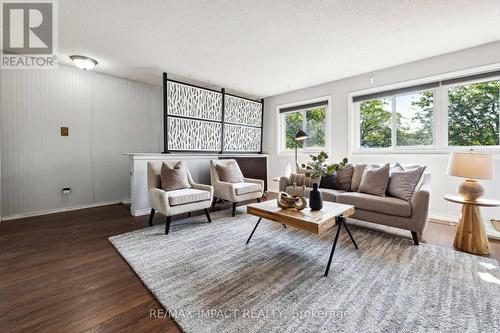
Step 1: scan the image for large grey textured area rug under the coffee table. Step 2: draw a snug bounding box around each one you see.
[110,207,500,333]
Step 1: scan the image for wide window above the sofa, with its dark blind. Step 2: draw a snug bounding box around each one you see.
[353,71,500,151]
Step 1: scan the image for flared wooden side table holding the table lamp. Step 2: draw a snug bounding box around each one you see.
[444,195,500,254]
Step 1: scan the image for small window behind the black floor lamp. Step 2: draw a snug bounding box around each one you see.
[279,101,328,151]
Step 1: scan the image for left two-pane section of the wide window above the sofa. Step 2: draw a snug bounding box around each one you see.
[359,90,434,148]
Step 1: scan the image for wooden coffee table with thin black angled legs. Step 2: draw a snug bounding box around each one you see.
[247,200,358,276]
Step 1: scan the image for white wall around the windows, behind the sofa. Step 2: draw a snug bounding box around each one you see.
[263,42,500,222]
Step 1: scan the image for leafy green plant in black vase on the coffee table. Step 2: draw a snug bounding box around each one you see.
[302,151,347,210]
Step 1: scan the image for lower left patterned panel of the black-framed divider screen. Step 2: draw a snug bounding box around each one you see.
[168,117,222,151]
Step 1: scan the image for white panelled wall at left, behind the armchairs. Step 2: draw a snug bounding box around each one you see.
[0,65,163,219]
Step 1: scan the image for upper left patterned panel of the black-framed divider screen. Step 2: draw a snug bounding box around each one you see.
[167,81,222,121]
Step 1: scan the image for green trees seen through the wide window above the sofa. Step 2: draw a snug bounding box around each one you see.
[360,81,500,148]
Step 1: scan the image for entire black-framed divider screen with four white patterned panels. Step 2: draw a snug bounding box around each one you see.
[163,73,263,153]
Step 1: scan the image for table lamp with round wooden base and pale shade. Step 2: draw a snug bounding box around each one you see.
[447,150,493,201]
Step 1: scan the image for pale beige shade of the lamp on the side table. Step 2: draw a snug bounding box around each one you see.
[447,151,493,179]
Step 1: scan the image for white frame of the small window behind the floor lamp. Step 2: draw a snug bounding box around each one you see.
[276,96,332,156]
